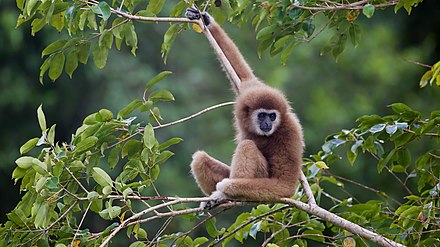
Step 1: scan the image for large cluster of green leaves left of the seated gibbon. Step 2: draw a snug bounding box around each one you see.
[0,71,182,246]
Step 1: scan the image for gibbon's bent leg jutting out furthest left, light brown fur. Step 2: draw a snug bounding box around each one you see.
[191,151,230,196]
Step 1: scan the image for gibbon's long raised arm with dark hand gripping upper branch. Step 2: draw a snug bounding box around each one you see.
[186,8,255,86]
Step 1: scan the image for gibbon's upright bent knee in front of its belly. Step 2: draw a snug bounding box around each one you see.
[230,140,269,178]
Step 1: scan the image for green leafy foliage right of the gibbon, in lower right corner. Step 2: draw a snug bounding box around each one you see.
[313,103,440,246]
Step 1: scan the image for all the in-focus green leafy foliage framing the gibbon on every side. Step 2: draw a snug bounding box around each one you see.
[0,0,440,247]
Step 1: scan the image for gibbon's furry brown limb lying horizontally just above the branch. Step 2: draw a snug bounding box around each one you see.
[216,178,297,201]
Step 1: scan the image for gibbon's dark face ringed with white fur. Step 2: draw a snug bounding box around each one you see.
[252,108,280,136]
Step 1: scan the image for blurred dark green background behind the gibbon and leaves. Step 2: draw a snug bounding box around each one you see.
[0,0,440,241]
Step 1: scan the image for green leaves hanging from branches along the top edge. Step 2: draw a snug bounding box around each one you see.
[17,0,438,84]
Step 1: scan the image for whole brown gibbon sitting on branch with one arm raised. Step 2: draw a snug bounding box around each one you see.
[186,8,304,208]
